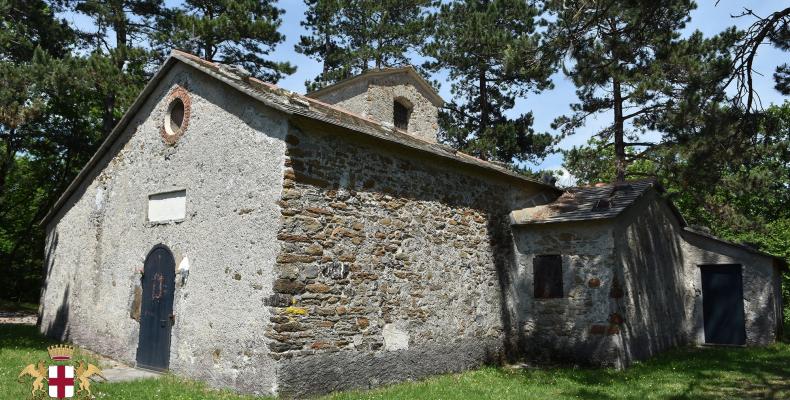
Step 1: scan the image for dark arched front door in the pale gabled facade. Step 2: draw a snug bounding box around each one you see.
[137,244,176,371]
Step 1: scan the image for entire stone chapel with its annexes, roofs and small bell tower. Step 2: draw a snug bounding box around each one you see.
[40,51,786,397]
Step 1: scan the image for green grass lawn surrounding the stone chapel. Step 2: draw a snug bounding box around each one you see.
[0,325,790,400]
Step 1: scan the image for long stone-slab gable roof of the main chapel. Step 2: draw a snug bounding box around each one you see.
[39,50,559,225]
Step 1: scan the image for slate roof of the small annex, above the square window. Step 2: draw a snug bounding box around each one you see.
[512,179,658,225]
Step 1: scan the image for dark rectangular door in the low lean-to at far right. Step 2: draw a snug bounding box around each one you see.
[700,264,746,345]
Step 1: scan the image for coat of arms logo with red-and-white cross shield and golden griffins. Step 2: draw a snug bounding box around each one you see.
[17,345,106,399]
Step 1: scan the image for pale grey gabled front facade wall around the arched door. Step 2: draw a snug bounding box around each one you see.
[41,64,287,393]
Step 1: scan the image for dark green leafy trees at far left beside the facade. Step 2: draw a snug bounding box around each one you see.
[0,1,101,301]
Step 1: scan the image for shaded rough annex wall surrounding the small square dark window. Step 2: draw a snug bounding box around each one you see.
[511,222,623,366]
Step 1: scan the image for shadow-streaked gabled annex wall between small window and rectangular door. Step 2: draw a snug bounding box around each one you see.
[615,192,702,363]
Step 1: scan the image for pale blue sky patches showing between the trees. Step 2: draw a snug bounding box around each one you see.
[62,0,790,184]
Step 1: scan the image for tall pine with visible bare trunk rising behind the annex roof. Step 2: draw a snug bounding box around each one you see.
[549,0,734,181]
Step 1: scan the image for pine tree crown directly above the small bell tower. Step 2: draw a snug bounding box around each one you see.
[296,0,431,91]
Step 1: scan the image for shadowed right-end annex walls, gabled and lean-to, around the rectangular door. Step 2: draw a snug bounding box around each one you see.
[615,191,781,362]
